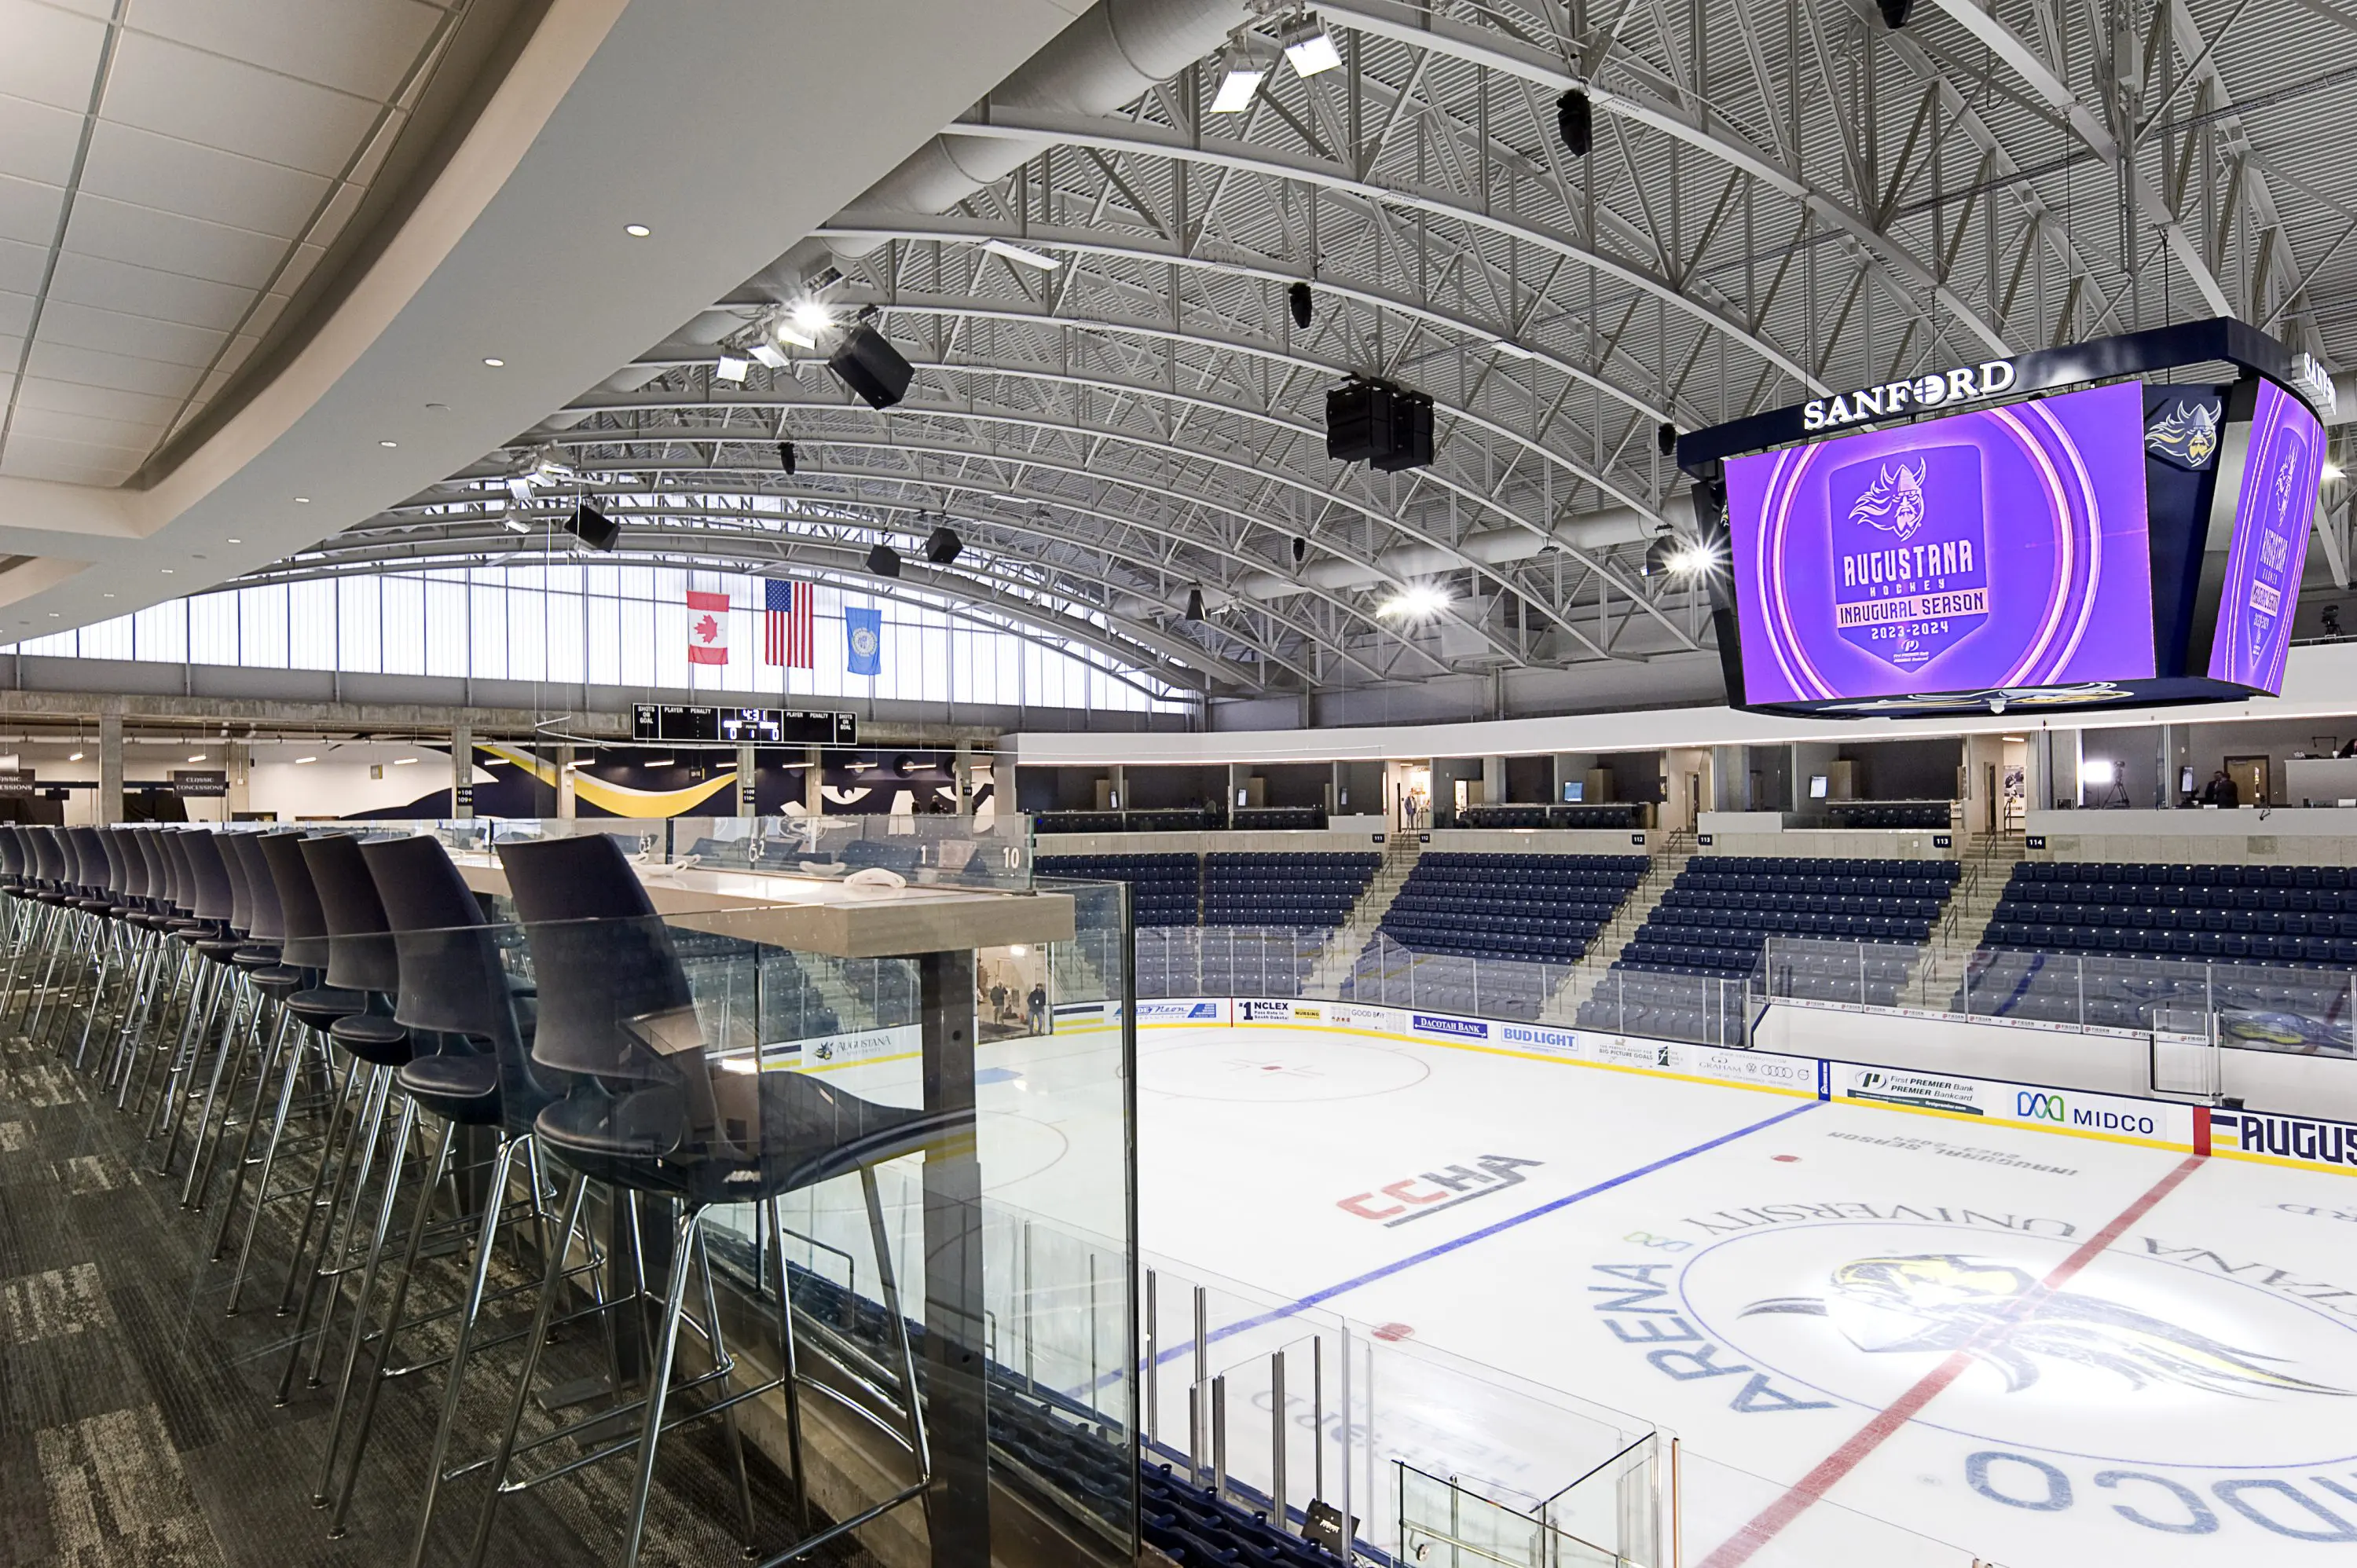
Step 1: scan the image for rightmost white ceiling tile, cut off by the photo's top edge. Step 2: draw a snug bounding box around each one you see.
[130,0,441,99]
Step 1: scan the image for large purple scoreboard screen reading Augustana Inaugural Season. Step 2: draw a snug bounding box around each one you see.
[1728,384,2154,705]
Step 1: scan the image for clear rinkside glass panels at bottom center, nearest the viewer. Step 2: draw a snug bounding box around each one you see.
[1138,1255,1975,1568]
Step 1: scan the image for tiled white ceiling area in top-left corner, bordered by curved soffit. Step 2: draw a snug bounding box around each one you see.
[0,0,469,471]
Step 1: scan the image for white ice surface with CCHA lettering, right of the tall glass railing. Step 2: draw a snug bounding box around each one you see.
[1117,1026,2357,1568]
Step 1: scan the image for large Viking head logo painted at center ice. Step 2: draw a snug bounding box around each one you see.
[1744,1252,2348,1398]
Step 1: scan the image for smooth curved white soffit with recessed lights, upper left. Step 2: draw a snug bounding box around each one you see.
[0,0,1087,636]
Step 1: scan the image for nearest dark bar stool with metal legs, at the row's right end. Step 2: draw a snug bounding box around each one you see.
[460,835,948,1568]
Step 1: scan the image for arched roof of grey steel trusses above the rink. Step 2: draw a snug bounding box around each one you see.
[337,0,2357,693]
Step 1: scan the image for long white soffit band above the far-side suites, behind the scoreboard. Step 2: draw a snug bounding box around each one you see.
[999,641,2357,766]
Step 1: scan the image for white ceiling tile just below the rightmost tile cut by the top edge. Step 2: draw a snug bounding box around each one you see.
[106,33,377,174]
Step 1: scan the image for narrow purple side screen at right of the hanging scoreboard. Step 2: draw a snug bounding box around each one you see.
[2209,382,2324,695]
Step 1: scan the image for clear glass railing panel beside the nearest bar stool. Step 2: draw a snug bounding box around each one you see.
[280,821,1138,1566]
